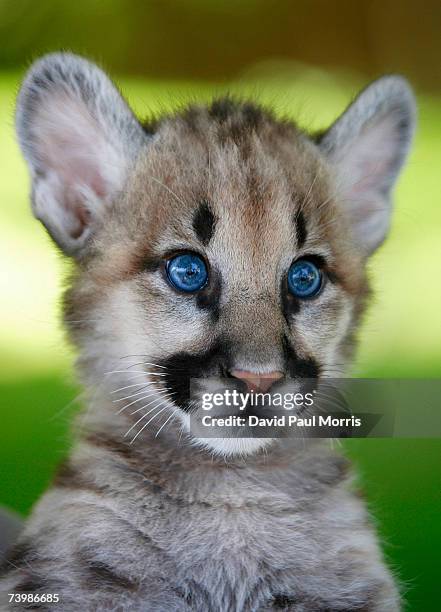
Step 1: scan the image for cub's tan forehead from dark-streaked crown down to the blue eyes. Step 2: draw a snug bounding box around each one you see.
[96,98,358,294]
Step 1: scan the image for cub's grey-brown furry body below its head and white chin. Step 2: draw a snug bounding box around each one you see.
[2,426,398,612]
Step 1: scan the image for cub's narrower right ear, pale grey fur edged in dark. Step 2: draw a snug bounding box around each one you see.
[319,76,416,255]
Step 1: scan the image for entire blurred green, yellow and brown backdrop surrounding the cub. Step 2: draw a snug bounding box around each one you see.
[0,0,441,612]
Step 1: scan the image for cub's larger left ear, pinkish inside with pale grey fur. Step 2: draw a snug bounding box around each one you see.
[16,53,146,257]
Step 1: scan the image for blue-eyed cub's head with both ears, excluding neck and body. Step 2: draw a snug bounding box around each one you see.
[17,54,415,453]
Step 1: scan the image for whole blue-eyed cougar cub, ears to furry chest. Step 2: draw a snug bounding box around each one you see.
[0,53,415,612]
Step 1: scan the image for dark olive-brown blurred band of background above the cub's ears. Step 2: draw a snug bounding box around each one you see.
[0,0,441,91]
